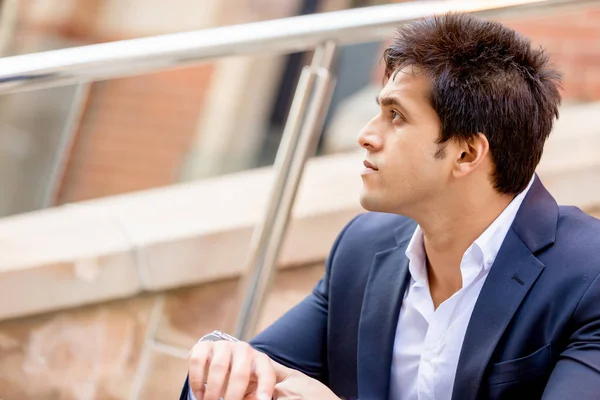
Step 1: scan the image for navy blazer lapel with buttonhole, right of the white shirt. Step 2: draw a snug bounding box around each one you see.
[452,178,558,400]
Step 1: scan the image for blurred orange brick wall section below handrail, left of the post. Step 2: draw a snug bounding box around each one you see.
[58,65,213,203]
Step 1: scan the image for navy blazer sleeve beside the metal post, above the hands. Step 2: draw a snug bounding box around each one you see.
[250,217,359,384]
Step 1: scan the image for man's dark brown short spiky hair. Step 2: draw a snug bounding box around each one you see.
[383,14,561,194]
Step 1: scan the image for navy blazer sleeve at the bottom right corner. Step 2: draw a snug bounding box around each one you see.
[542,270,600,400]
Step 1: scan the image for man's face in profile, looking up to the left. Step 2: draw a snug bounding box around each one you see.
[358,66,452,216]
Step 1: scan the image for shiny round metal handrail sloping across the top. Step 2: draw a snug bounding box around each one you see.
[0,0,595,94]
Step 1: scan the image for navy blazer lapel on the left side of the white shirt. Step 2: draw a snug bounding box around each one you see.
[358,242,410,399]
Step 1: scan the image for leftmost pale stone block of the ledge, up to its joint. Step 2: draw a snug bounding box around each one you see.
[0,207,140,319]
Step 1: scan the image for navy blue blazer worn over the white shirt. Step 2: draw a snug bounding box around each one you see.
[182,178,600,400]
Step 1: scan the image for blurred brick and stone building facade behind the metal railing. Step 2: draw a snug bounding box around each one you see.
[0,0,600,216]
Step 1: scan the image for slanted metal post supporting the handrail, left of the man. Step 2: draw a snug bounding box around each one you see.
[234,42,337,340]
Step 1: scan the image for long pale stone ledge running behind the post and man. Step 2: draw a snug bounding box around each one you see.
[0,106,600,320]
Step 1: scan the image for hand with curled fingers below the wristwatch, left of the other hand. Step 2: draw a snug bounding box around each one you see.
[188,341,276,400]
